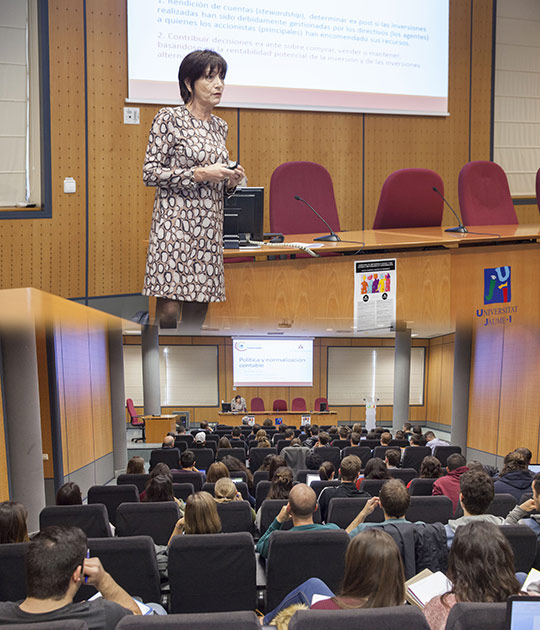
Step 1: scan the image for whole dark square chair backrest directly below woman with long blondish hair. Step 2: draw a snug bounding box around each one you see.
[169,532,257,613]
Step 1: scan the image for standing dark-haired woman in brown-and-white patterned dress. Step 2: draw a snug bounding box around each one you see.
[142,50,245,332]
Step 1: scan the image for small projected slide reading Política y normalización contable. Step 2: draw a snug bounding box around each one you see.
[233,338,313,387]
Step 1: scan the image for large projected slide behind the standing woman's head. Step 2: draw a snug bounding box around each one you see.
[127,0,449,115]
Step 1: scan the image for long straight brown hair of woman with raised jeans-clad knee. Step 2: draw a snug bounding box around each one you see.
[333,527,405,608]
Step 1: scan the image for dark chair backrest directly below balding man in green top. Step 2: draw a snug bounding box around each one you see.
[266,529,350,610]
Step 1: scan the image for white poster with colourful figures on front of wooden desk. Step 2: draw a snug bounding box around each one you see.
[354,258,397,332]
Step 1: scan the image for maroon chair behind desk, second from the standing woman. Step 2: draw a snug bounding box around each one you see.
[373,168,444,230]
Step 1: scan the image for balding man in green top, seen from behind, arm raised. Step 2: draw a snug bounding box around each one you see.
[256,483,339,558]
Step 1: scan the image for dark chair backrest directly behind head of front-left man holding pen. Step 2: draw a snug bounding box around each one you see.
[39,503,113,538]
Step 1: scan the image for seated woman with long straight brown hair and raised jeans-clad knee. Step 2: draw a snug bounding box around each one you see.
[263,529,405,628]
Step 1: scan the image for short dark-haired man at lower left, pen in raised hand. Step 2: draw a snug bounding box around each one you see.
[0,527,150,630]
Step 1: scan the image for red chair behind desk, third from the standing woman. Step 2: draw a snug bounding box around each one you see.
[458,161,518,225]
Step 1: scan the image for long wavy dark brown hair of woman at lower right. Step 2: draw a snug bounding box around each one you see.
[443,521,520,603]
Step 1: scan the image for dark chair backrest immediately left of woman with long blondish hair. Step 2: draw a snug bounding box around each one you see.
[116,501,180,545]
